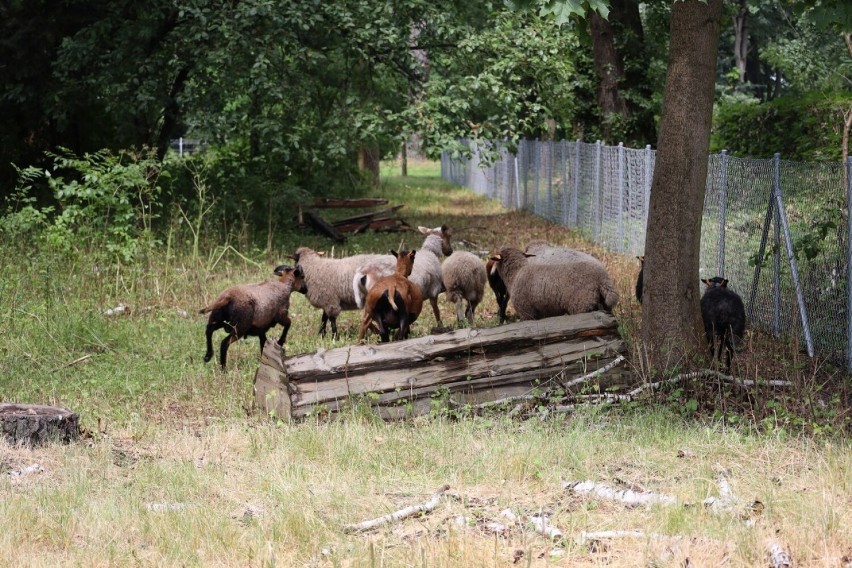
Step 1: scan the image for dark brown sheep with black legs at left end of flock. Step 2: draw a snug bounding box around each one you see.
[199,266,305,369]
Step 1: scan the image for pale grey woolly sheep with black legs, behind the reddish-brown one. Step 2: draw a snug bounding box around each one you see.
[293,247,393,337]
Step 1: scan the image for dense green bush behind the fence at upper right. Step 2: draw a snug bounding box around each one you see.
[710,93,852,162]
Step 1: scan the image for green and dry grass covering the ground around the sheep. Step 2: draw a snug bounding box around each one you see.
[0,164,852,566]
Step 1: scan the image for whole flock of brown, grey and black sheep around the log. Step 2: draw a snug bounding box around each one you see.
[200,225,745,368]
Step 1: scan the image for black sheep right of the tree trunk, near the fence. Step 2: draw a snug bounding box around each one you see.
[701,276,745,370]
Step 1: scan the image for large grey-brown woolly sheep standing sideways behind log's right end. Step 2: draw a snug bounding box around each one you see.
[491,247,618,320]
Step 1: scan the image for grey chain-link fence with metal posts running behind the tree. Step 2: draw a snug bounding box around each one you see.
[441,141,852,370]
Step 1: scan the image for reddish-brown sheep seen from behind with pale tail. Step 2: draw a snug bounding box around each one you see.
[358,250,423,343]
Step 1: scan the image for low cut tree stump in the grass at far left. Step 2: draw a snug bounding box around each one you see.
[0,403,80,446]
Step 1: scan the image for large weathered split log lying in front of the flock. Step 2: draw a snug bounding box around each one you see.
[255,312,626,418]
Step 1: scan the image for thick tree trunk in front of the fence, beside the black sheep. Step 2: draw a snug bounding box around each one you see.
[642,0,722,371]
